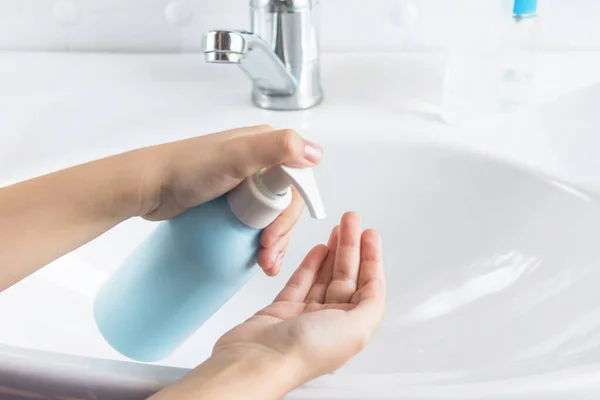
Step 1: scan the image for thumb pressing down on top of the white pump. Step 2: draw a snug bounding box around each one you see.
[222,129,323,179]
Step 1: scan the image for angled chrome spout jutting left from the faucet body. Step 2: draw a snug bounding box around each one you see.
[204,30,298,96]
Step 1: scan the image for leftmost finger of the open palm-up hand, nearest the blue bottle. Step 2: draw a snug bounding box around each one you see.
[275,245,329,302]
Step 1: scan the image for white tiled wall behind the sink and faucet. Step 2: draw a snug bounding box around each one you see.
[0,0,600,52]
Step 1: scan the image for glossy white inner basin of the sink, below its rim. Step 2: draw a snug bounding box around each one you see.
[0,141,600,399]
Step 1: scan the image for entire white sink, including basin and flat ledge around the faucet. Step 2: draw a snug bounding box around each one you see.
[0,53,600,400]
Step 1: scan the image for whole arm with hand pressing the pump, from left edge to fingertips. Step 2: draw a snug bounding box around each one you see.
[0,126,321,291]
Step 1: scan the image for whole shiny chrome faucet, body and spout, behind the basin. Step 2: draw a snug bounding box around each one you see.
[204,0,323,110]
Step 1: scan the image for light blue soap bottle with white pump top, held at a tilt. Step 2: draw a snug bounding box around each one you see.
[94,165,325,362]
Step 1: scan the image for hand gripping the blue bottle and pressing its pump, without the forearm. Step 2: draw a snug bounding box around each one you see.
[140,126,322,276]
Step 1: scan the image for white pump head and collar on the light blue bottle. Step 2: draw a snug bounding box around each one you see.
[227,165,325,229]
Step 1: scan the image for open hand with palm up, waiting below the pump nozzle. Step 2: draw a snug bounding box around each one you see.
[214,213,385,380]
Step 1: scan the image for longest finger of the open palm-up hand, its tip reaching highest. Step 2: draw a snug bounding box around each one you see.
[325,212,361,303]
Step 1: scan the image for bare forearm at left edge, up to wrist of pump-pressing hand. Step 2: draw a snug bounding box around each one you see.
[0,151,157,291]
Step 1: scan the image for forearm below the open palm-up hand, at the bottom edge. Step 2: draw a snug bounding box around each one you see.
[150,351,303,400]
